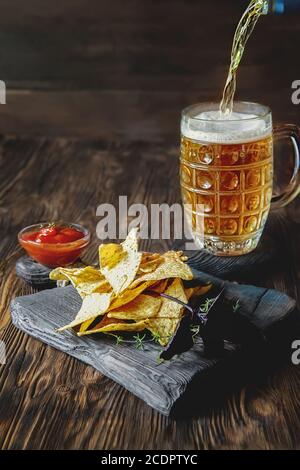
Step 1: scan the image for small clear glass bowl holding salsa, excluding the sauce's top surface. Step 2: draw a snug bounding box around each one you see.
[18,222,91,268]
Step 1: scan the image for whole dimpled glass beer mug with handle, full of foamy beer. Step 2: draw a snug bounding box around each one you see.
[180,102,300,256]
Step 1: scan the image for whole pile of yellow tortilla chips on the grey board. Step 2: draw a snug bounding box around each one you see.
[50,229,203,346]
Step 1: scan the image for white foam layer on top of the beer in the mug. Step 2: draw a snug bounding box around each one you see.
[181,111,272,144]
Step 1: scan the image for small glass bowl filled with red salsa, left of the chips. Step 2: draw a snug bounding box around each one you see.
[18,222,91,268]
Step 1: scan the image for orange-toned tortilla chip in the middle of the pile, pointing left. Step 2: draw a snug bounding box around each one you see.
[107,294,162,321]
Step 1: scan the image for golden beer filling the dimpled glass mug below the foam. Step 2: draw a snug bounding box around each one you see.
[180,103,273,255]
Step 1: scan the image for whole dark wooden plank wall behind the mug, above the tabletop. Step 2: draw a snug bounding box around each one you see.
[0,0,300,140]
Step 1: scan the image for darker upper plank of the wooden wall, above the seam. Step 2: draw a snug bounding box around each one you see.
[0,0,299,93]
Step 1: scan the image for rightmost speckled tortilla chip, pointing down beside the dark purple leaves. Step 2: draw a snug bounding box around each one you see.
[146,279,187,346]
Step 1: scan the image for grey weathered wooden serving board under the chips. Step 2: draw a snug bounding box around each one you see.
[11,273,295,415]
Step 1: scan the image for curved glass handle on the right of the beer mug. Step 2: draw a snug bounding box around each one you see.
[271,124,300,209]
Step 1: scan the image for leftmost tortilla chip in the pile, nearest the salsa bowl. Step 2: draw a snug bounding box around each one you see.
[49,266,111,298]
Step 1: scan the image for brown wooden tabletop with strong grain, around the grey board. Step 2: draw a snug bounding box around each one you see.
[0,137,300,449]
